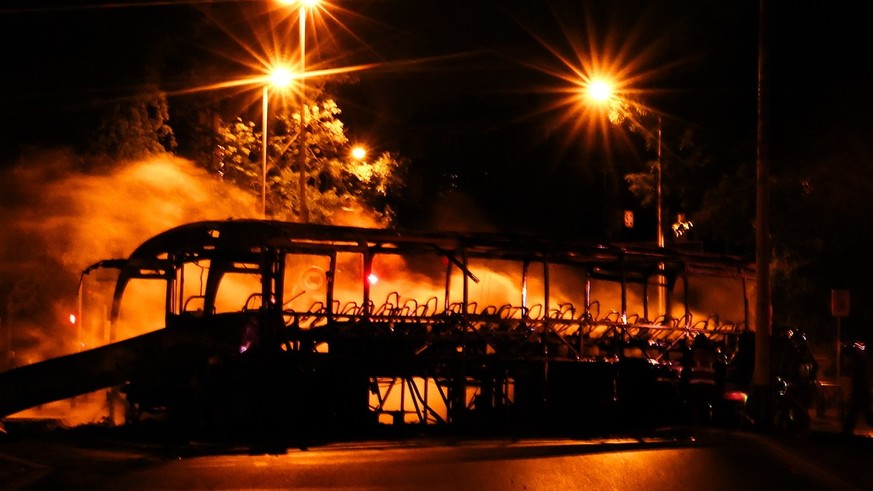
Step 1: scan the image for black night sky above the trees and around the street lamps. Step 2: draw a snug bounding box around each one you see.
[0,0,873,238]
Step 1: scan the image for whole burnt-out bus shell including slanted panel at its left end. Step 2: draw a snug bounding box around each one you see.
[0,220,750,433]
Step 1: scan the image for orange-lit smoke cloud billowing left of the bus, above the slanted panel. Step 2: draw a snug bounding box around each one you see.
[0,150,259,369]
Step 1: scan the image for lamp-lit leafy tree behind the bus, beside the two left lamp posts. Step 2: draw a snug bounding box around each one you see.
[216,99,407,225]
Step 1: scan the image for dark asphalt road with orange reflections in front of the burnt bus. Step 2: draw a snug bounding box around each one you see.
[0,429,873,491]
